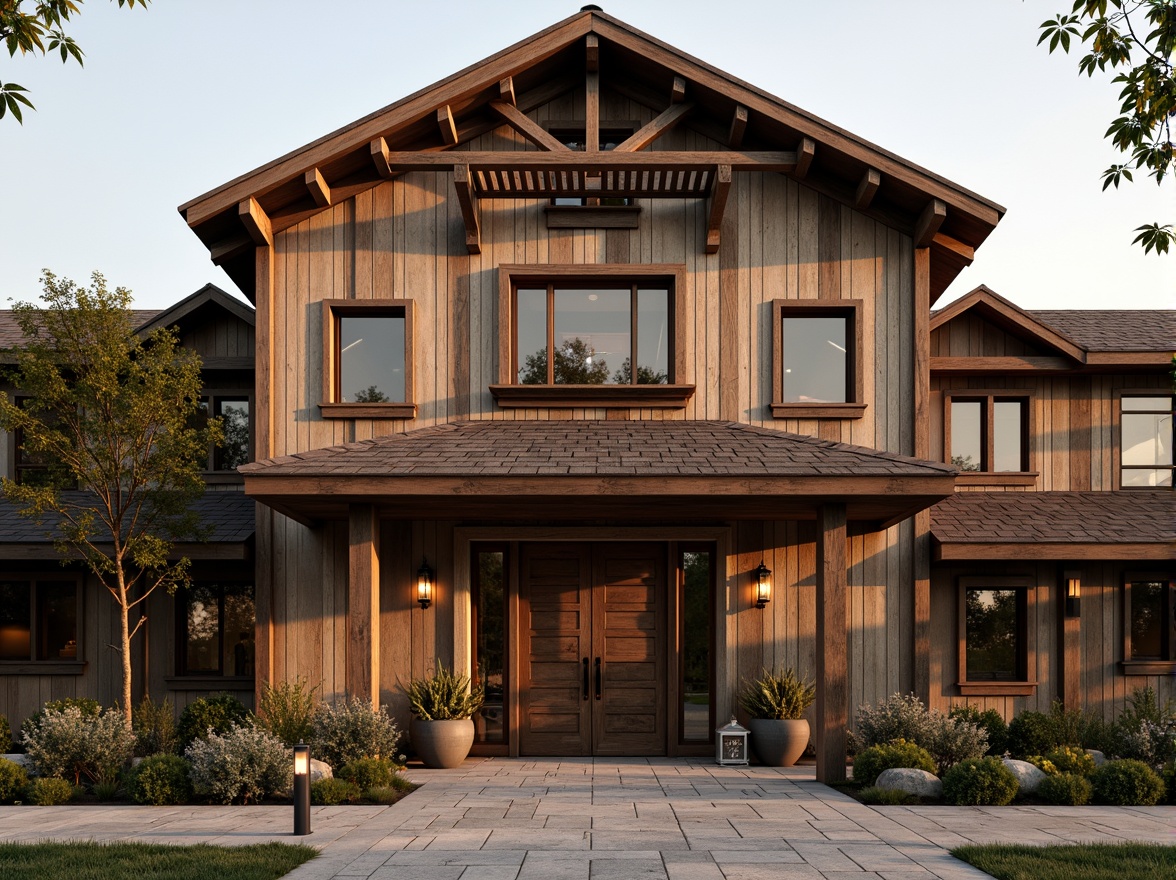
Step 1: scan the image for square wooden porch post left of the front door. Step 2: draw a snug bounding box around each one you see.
[347,505,380,706]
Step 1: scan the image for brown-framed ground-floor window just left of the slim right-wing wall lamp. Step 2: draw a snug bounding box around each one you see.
[958,576,1036,695]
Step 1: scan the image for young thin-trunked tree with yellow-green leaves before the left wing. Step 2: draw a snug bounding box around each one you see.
[0,271,221,725]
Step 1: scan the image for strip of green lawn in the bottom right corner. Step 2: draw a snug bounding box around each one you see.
[951,844,1176,880]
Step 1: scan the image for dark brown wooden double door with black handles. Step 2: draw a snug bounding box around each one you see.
[519,544,667,755]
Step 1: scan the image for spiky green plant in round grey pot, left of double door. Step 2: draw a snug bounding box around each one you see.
[405,661,483,769]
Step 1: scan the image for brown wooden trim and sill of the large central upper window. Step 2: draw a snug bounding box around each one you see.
[489,264,695,409]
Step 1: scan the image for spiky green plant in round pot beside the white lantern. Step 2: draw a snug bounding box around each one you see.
[739,669,816,767]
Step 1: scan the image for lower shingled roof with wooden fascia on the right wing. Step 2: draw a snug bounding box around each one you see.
[931,489,1176,560]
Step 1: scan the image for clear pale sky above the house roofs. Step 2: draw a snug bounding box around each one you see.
[0,0,1176,308]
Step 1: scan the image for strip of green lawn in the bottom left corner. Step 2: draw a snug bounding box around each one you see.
[0,844,319,880]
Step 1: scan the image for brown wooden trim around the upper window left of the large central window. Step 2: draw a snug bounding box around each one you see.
[319,299,416,419]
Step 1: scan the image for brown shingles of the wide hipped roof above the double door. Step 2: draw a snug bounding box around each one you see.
[239,421,955,476]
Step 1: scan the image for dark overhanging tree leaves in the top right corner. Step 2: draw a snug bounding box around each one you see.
[1037,0,1176,254]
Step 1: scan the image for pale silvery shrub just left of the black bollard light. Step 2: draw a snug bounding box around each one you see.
[183,725,294,804]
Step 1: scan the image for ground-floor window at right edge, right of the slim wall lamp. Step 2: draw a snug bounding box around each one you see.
[1123,572,1176,675]
